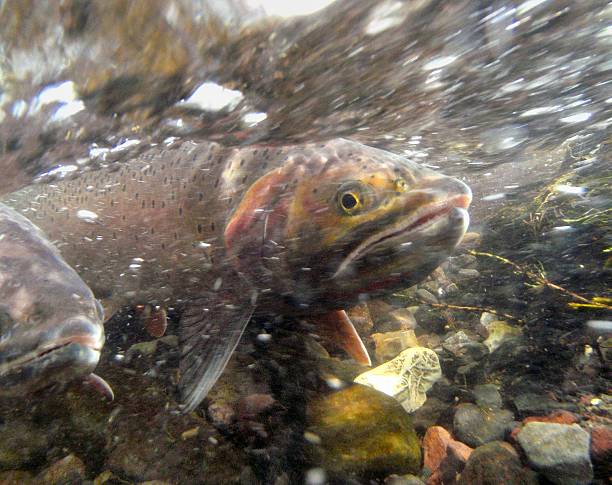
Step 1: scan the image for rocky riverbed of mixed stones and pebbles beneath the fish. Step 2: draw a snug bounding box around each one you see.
[0,235,612,485]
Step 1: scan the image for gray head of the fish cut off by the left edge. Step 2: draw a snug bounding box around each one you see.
[0,204,104,397]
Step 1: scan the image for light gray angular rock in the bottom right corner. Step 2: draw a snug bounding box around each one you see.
[517,422,593,485]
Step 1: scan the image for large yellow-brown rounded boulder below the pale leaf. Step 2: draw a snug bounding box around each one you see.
[306,384,421,478]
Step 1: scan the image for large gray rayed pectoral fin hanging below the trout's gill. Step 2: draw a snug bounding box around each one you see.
[179,284,255,413]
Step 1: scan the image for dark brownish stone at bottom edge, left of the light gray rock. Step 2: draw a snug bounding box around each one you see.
[457,441,539,485]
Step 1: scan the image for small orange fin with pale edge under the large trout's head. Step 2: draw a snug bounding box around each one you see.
[314,310,372,365]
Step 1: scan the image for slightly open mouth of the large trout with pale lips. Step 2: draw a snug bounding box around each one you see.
[332,192,472,279]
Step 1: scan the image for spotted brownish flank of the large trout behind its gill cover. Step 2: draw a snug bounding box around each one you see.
[6,143,274,313]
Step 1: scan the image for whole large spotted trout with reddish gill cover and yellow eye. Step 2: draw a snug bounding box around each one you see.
[4,139,471,411]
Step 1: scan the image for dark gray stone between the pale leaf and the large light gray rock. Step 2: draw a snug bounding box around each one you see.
[453,403,514,448]
